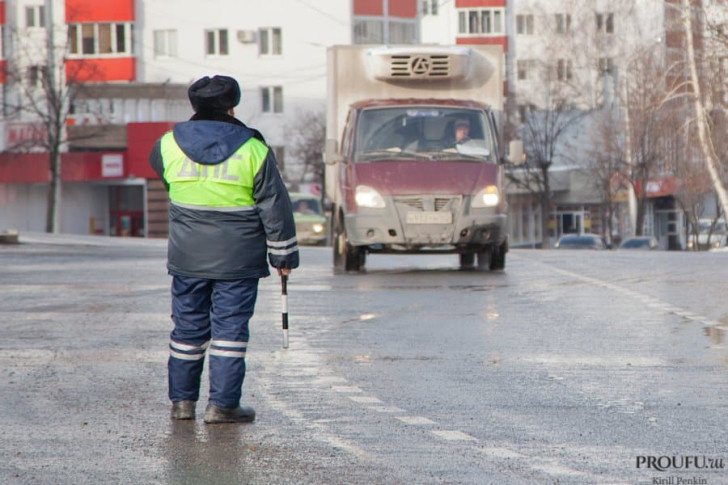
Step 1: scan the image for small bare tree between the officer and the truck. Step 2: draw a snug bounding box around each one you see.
[288,110,326,184]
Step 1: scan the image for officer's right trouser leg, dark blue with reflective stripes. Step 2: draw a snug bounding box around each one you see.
[209,278,258,408]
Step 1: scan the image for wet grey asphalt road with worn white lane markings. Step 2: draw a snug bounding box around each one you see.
[0,235,728,485]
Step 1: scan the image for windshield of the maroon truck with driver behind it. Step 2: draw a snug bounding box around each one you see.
[354,106,496,163]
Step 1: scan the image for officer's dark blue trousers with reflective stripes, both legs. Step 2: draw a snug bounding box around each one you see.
[167,276,258,407]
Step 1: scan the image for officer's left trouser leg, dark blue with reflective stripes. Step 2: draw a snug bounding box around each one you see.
[167,276,213,401]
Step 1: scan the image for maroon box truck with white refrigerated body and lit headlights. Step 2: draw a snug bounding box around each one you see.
[324,46,523,271]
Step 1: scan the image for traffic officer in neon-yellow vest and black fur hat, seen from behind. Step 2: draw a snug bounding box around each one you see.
[149,76,299,423]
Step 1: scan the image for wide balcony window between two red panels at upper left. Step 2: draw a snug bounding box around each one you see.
[68,23,131,57]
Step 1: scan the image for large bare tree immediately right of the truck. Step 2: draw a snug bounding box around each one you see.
[510,0,648,247]
